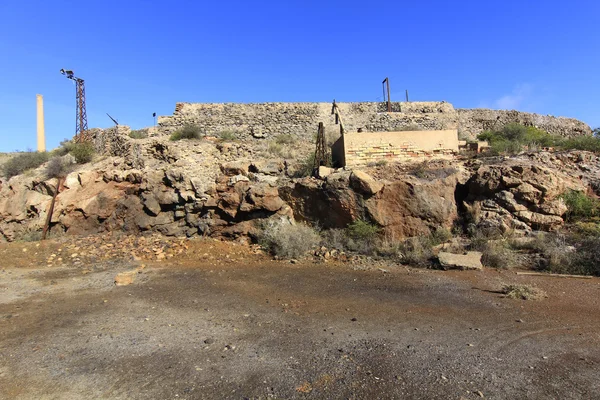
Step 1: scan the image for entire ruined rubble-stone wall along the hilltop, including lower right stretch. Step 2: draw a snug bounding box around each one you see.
[158,102,591,140]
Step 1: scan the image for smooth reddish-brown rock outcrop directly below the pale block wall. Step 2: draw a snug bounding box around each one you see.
[280,171,465,239]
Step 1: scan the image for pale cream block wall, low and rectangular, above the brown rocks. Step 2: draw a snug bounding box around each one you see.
[343,129,458,166]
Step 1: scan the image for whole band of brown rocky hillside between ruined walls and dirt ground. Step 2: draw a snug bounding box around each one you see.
[0,130,600,241]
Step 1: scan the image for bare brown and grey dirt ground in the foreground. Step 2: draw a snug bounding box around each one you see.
[0,236,600,400]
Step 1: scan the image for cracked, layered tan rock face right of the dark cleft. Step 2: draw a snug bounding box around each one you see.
[465,161,585,232]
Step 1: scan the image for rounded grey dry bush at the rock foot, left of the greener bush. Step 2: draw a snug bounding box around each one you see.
[259,220,321,258]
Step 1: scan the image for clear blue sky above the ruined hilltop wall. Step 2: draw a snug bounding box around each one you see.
[0,0,600,151]
